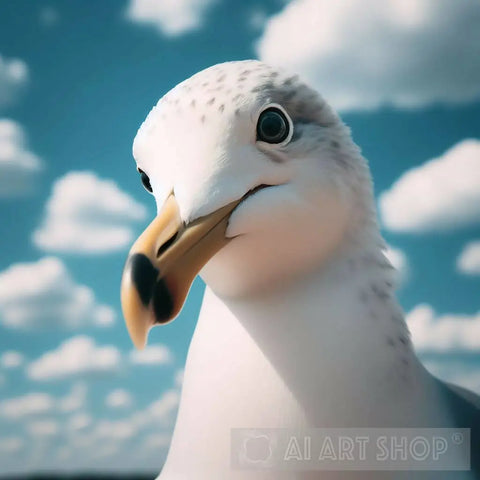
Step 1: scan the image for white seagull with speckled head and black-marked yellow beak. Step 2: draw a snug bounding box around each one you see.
[121,60,480,480]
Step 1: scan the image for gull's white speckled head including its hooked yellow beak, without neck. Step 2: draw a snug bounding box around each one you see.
[122,61,373,348]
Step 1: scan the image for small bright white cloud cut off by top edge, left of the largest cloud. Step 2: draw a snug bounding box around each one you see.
[126,0,216,37]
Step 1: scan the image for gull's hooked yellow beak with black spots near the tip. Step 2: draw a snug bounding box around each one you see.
[121,194,240,349]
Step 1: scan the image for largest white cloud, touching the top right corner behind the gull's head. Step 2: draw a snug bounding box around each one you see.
[257,0,480,110]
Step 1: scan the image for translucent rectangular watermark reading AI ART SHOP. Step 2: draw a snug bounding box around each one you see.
[231,428,470,471]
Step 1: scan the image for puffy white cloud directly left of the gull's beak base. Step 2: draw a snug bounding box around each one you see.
[33,172,147,254]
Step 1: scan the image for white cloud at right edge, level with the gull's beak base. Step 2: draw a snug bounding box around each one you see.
[379,140,480,232]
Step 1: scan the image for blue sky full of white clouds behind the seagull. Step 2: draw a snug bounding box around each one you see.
[0,0,480,474]
